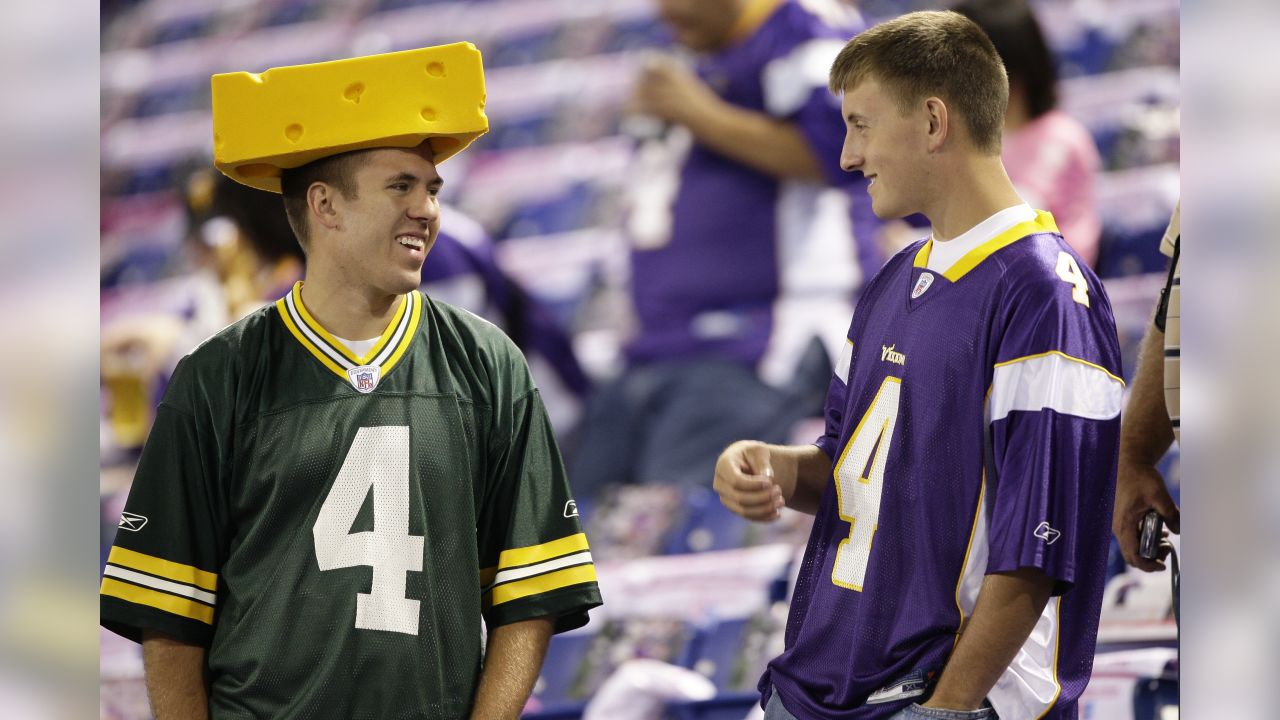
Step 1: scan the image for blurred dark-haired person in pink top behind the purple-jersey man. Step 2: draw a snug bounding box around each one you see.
[952,0,1102,268]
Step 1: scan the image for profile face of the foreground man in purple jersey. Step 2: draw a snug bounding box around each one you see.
[840,77,929,220]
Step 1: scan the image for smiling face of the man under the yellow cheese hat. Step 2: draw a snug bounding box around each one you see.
[315,143,444,295]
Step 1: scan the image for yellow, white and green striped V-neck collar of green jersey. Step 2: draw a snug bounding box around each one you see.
[275,282,422,392]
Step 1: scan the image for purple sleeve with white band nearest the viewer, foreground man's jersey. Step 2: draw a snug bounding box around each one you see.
[987,250,1124,594]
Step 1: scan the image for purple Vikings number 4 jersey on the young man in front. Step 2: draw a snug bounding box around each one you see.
[760,213,1123,720]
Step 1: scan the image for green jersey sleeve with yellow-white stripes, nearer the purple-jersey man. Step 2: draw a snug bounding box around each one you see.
[477,389,602,633]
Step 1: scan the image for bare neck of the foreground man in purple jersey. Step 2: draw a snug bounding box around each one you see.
[925,155,1023,242]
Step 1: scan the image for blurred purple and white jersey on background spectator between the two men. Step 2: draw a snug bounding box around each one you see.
[627,0,882,382]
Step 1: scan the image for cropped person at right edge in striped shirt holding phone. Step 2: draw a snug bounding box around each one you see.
[1111,199,1181,573]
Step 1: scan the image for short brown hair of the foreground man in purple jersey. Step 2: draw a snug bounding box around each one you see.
[831,10,1009,155]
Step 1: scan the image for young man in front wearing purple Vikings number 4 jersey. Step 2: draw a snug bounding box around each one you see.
[714,12,1123,720]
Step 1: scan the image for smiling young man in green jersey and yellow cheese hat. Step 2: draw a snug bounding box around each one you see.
[101,44,600,720]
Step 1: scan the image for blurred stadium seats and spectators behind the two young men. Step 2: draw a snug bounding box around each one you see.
[100,0,1180,720]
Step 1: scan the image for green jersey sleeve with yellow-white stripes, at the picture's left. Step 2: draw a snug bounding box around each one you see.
[100,359,230,646]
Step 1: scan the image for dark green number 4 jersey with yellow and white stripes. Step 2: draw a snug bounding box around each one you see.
[101,283,600,720]
